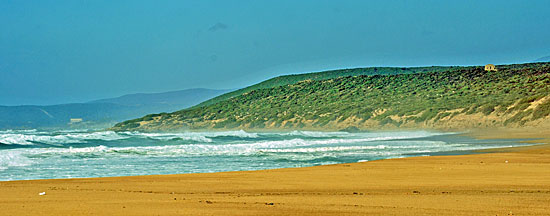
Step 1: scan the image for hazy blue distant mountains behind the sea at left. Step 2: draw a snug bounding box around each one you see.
[0,89,230,129]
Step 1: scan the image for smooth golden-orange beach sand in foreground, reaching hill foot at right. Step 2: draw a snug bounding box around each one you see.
[0,129,550,215]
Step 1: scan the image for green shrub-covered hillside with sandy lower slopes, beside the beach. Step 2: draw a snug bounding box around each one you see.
[112,63,550,131]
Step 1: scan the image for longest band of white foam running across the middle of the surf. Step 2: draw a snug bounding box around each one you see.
[19,138,445,157]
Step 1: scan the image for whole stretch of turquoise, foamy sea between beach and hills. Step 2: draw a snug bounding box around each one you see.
[0,130,536,181]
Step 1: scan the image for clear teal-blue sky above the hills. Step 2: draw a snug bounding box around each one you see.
[0,0,550,105]
